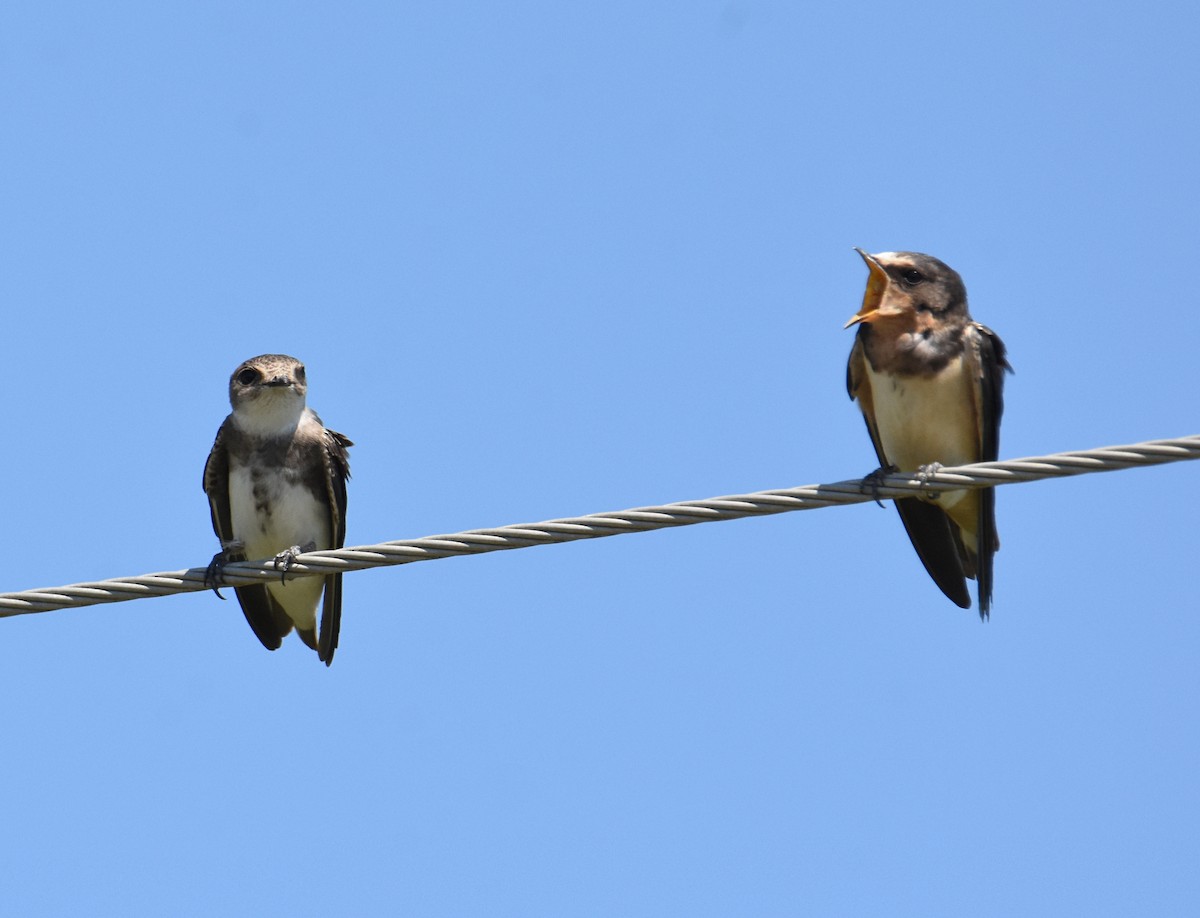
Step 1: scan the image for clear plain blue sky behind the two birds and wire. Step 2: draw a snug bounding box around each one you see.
[0,0,1200,916]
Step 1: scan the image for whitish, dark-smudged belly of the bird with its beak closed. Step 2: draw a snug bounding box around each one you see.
[229,467,332,629]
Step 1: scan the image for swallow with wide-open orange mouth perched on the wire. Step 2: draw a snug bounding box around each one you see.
[846,248,1012,620]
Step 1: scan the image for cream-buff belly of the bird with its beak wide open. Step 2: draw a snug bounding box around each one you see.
[866,358,979,508]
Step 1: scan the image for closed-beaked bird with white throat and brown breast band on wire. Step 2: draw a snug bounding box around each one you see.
[204,354,354,666]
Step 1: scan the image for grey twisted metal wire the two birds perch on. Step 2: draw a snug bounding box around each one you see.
[0,434,1200,618]
